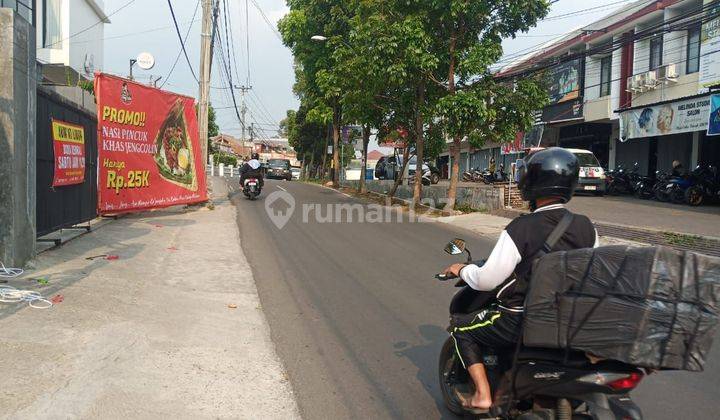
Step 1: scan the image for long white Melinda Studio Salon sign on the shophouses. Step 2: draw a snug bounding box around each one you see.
[620,96,710,141]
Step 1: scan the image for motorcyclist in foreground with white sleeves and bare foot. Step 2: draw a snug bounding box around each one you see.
[445,147,598,412]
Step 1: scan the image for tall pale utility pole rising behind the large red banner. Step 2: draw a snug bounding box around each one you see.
[198,0,212,168]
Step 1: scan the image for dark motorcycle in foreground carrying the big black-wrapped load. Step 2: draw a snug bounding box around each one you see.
[435,239,645,420]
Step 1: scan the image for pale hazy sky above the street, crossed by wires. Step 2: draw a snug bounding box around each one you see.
[103,0,631,143]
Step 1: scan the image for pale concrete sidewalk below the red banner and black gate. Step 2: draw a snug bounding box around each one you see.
[0,178,299,419]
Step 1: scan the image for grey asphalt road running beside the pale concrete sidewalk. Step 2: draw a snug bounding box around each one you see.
[233,181,720,419]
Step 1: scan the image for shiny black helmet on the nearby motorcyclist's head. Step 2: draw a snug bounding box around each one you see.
[518,147,580,203]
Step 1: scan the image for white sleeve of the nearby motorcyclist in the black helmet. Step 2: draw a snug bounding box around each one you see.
[460,230,522,291]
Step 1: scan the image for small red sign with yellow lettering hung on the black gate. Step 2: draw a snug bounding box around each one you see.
[50,119,85,187]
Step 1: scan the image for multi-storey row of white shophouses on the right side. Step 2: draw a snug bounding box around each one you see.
[478,0,720,175]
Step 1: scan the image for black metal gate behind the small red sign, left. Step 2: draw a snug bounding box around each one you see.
[35,87,97,237]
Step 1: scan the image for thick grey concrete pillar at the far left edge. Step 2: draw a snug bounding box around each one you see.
[0,8,37,267]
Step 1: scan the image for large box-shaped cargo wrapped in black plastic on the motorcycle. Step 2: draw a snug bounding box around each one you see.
[524,246,720,371]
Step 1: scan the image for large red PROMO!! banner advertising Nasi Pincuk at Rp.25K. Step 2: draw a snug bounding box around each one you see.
[95,73,207,214]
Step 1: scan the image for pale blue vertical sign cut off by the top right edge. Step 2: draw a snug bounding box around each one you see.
[699,0,720,93]
